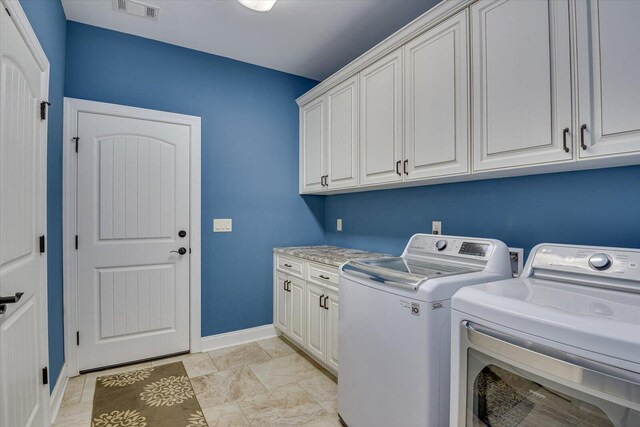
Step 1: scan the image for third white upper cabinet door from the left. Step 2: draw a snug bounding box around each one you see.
[360,49,403,185]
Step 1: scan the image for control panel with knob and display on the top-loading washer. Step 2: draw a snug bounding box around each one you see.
[406,234,494,260]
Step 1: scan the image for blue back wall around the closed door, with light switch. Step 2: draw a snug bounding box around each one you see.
[65,22,324,336]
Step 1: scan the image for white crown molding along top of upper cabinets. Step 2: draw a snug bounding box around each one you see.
[296,0,477,106]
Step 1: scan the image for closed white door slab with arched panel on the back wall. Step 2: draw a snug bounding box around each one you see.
[77,112,190,371]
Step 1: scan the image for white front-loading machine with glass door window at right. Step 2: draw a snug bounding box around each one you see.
[450,244,640,427]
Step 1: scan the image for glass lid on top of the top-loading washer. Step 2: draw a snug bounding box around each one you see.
[342,257,481,290]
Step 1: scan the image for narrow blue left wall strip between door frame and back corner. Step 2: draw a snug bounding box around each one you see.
[20,0,67,389]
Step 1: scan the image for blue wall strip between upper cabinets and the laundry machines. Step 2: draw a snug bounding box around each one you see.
[325,166,640,260]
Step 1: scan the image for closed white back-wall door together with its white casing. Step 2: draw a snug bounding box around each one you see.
[64,99,201,376]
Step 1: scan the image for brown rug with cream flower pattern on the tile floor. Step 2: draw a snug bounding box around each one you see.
[91,362,207,427]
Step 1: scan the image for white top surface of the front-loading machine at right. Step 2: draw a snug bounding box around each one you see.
[451,278,640,363]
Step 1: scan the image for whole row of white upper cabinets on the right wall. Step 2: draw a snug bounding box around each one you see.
[297,0,640,194]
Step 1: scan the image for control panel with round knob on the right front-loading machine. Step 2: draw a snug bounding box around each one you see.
[532,245,640,280]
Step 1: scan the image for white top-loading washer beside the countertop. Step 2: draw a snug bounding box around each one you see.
[338,234,511,427]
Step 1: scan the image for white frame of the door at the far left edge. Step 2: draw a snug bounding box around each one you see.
[0,0,50,422]
